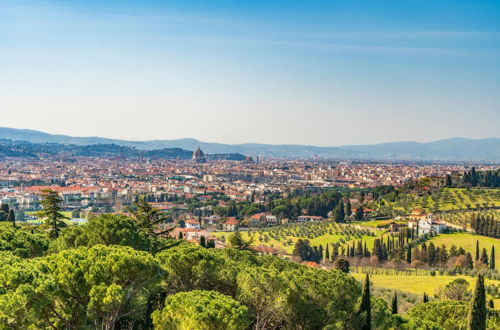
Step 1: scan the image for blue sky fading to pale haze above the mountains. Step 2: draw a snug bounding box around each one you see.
[0,0,500,146]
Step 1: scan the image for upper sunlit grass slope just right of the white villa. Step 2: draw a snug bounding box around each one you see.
[427,233,500,265]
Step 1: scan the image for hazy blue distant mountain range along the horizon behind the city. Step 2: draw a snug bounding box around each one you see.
[0,127,500,162]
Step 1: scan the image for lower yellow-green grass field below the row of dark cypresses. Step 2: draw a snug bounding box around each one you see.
[352,273,500,310]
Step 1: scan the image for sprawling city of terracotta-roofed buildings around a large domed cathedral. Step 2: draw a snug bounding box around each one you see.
[0,148,486,236]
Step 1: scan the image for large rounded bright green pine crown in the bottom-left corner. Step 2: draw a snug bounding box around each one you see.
[0,245,164,329]
